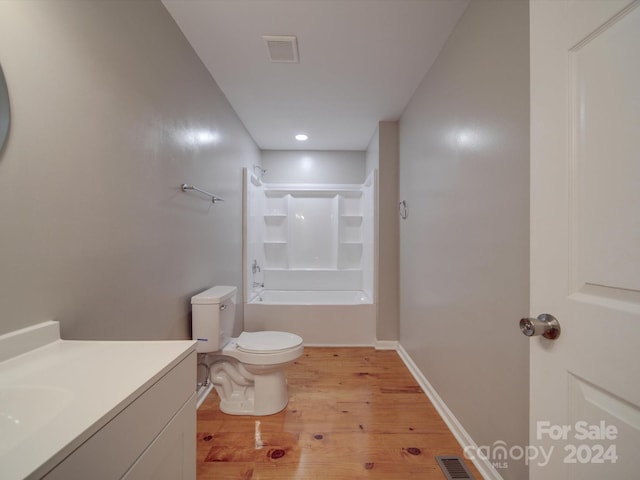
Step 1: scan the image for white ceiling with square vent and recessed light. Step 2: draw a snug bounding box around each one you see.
[162,0,468,150]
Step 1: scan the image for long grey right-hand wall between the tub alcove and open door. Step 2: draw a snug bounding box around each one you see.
[400,0,529,480]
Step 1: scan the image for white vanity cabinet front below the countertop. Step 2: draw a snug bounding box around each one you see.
[41,351,196,480]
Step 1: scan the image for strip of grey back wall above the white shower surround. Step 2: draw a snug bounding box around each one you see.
[262,150,366,184]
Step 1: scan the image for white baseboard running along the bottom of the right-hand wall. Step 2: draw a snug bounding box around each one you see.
[396,344,503,480]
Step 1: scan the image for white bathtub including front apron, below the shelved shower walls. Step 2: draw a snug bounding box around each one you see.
[244,290,376,346]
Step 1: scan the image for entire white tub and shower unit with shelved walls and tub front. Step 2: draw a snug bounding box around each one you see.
[244,173,376,345]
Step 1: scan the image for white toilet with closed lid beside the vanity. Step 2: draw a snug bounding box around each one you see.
[191,286,304,416]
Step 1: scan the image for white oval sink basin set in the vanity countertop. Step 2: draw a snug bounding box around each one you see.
[0,386,73,455]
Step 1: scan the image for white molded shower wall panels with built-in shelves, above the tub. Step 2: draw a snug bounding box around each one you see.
[246,171,374,301]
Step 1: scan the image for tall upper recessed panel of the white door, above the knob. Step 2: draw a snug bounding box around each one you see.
[569,4,640,292]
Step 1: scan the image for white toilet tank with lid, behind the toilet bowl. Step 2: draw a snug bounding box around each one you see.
[191,286,237,353]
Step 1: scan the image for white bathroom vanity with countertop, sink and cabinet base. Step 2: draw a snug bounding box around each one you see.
[0,321,196,480]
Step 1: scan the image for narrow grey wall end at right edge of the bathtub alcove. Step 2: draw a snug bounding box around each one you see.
[365,122,400,341]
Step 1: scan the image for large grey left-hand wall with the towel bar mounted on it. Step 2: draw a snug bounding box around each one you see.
[0,0,260,339]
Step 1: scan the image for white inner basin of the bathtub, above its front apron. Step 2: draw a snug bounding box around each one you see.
[249,290,372,305]
